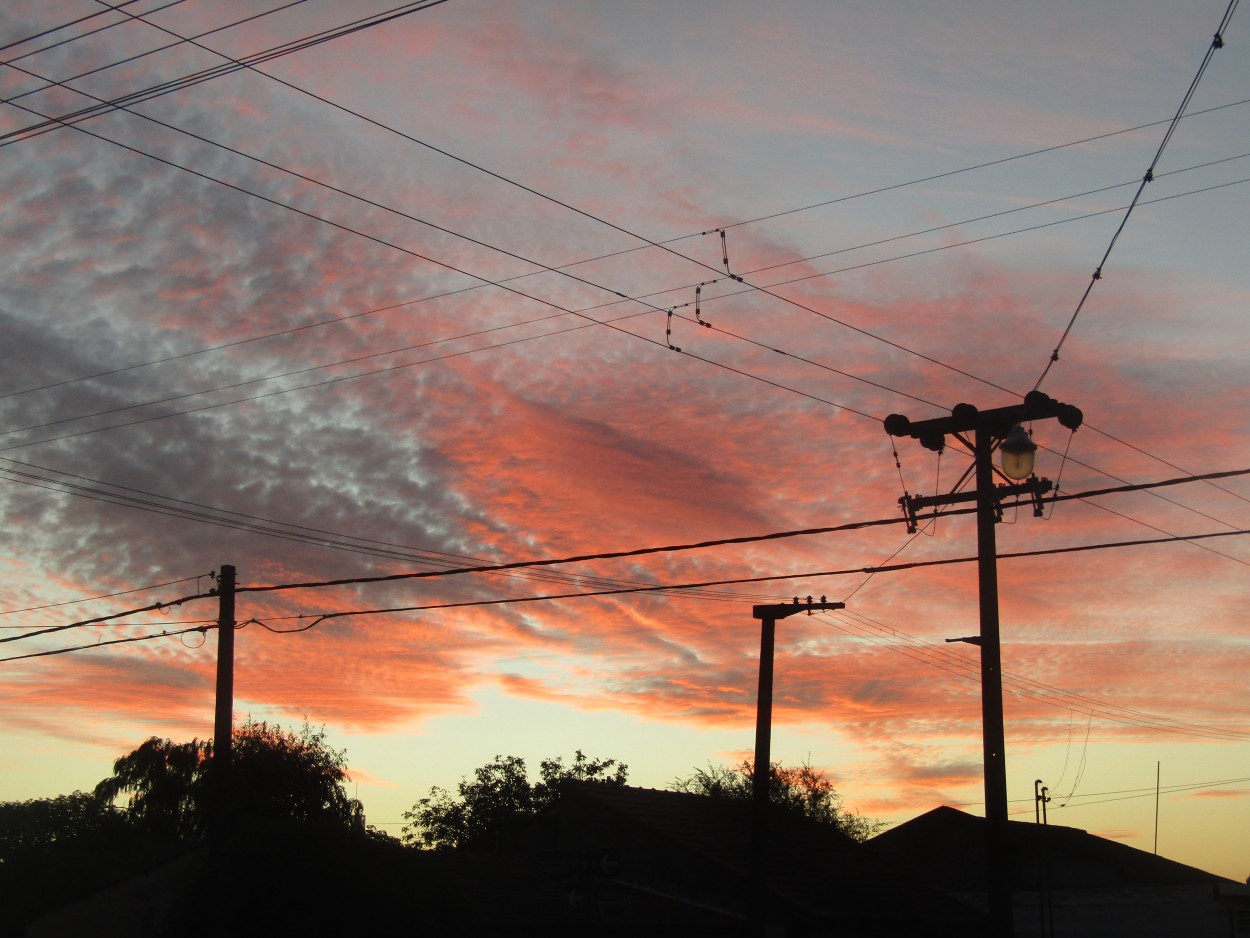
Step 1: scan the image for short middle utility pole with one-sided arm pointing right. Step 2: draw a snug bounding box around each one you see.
[750,597,846,934]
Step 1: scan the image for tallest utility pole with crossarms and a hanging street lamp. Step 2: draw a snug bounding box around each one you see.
[884,390,1084,938]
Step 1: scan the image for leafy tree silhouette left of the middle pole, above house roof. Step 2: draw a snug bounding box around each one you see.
[403,749,629,849]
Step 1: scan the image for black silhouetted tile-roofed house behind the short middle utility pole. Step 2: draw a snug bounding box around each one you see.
[502,782,983,937]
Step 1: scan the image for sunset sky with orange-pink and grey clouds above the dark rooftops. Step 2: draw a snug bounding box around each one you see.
[0,0,1250,880]
